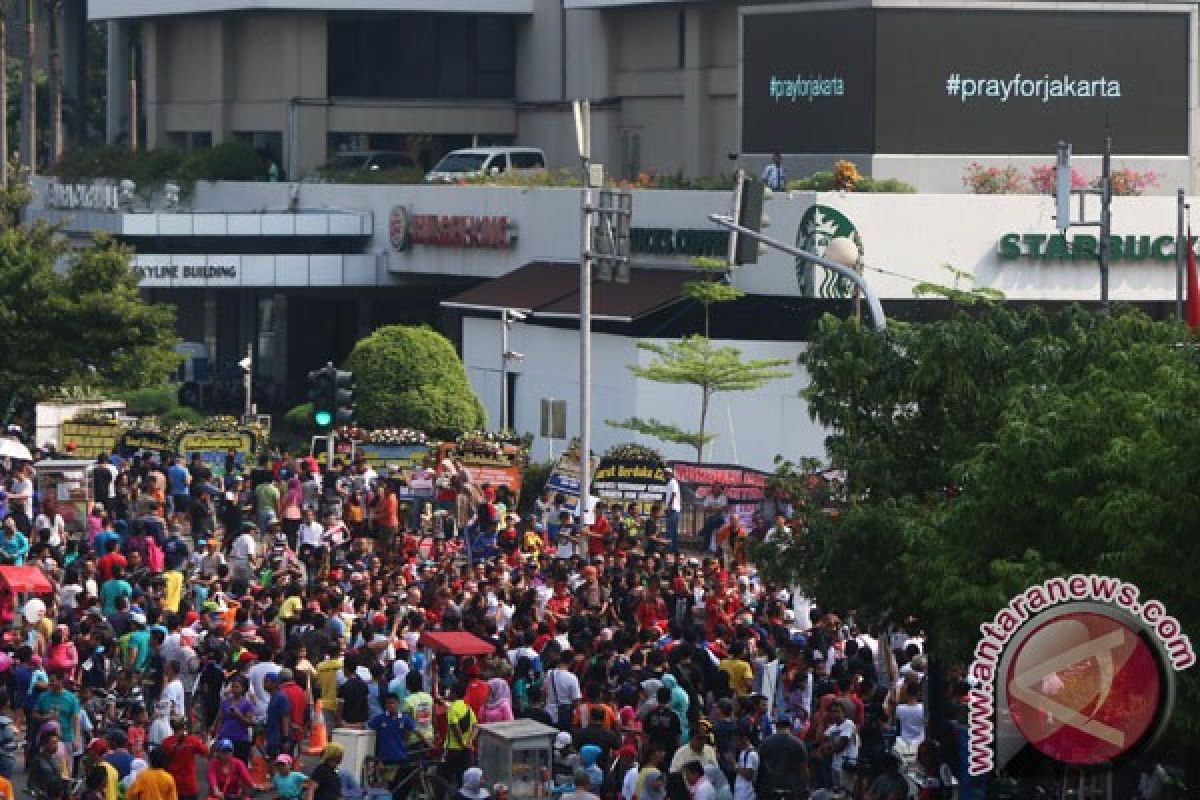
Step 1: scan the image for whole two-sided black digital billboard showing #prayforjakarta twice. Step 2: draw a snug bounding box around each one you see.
[742,8,1190,156]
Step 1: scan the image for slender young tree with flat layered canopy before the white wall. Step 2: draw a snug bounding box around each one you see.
[607,336,791,461]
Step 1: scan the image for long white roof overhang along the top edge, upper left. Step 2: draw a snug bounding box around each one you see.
[88,0,533,19]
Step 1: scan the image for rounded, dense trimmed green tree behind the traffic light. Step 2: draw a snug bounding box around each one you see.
[347,325,486,438]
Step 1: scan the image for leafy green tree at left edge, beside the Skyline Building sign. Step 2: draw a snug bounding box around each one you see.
[0,219,179,412]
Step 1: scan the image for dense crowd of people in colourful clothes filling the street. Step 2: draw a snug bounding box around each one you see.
[0,443,959,800]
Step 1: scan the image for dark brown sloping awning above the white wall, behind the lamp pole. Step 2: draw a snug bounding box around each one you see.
[442,261,700,323]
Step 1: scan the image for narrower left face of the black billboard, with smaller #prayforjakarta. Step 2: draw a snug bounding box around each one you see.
[742,8,875,152]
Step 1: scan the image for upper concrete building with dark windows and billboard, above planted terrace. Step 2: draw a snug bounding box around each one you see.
[89,0,1200,192]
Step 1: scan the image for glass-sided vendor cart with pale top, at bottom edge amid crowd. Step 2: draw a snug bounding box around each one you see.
[479,720,558,800]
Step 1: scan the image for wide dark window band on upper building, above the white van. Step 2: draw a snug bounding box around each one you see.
[328,12,516,100]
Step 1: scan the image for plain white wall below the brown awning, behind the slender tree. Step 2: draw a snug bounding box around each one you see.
[463,318,826,469]
